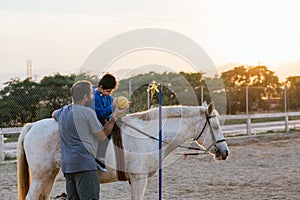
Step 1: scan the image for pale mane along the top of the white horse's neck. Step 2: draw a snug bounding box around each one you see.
[126,106,204,121]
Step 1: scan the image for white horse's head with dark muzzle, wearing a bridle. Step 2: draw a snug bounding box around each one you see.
[195,102,229,160]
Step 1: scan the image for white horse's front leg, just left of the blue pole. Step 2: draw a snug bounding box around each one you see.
[129,173,148,200]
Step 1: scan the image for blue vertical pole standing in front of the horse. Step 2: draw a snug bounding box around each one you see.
[158,84,162,200]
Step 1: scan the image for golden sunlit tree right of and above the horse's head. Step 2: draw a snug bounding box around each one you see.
[221,66,281,114]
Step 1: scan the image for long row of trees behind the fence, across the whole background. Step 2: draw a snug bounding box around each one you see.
[0,66,300,127]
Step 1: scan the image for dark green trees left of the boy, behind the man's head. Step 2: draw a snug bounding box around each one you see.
[0,73,99,127]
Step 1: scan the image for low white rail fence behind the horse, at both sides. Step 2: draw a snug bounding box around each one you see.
[0,112,300,162]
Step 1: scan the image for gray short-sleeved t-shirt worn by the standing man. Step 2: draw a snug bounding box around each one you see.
[54,104,103,173]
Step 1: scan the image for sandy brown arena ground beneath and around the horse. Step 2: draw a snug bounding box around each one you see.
[0,133,300,200]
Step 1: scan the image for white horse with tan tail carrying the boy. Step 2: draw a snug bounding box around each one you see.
[17,104,229,200]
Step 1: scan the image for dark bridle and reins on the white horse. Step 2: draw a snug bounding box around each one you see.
[118,112,226,156]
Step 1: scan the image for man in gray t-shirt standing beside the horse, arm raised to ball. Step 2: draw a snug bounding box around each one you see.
[52,81,126,200]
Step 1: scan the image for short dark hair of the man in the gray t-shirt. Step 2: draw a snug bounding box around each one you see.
[71,80,92,102]
